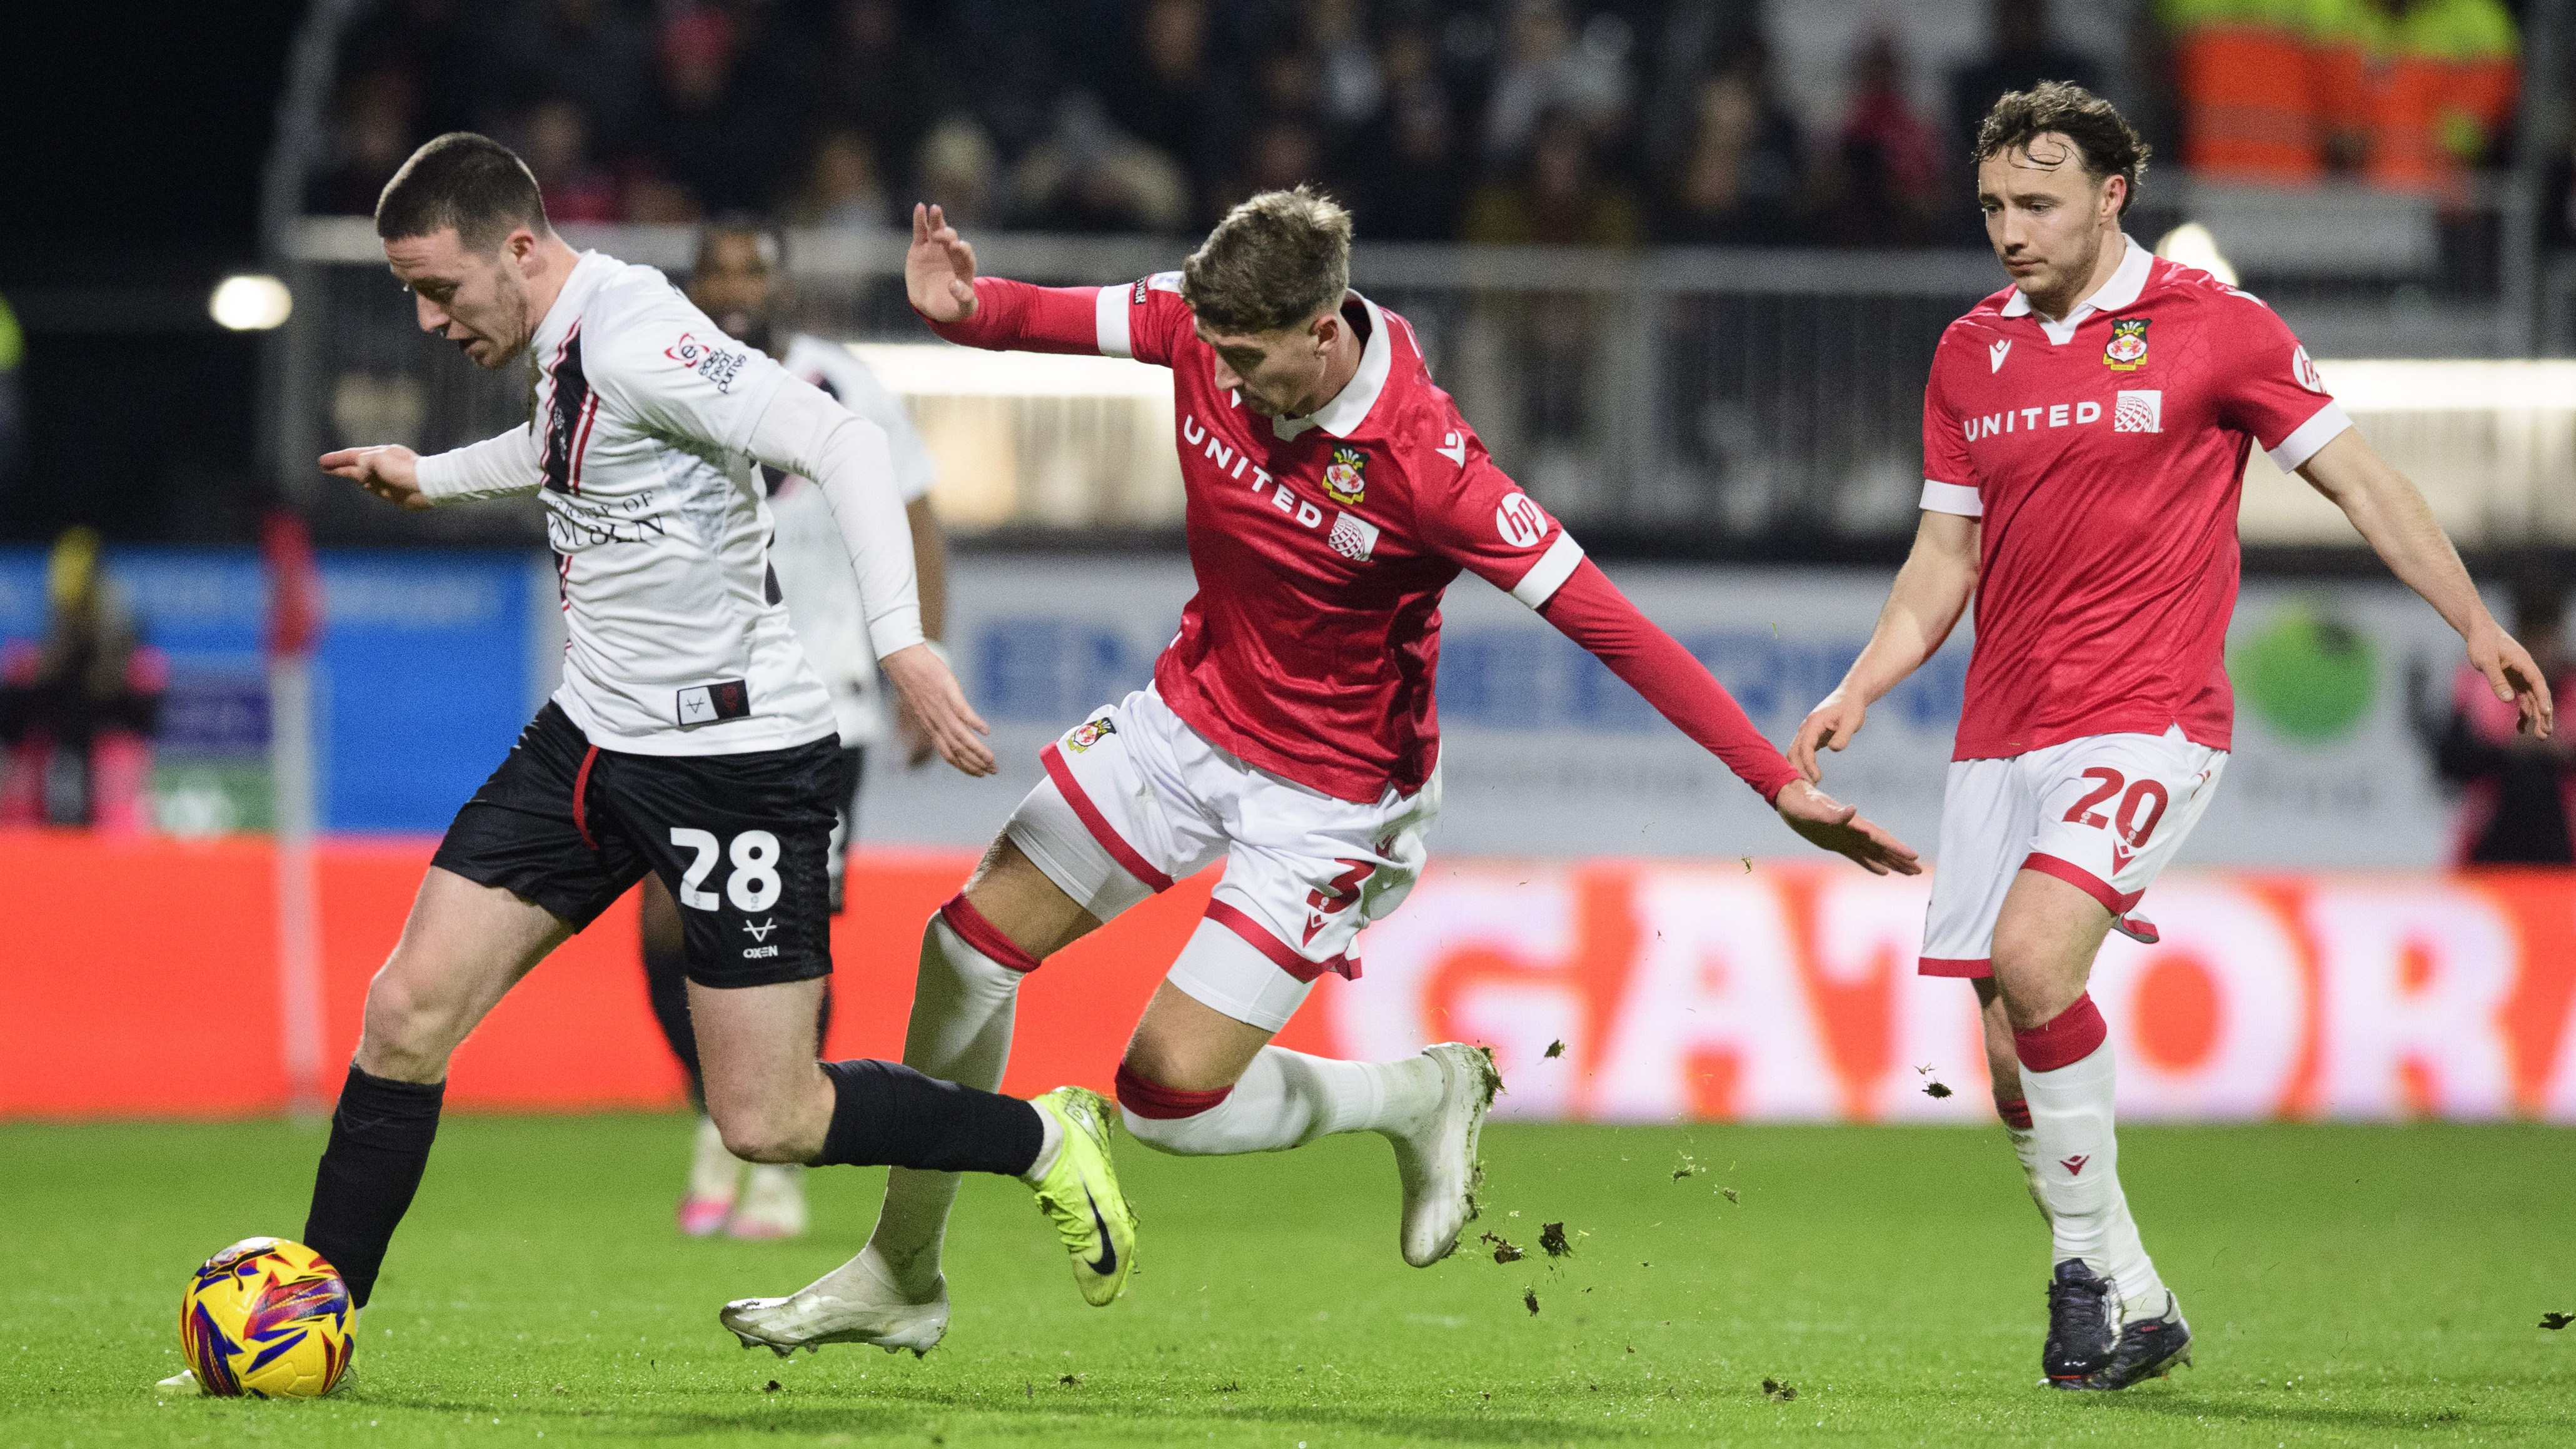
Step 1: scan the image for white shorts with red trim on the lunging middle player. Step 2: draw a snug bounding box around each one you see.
[1005,686,1440,1031]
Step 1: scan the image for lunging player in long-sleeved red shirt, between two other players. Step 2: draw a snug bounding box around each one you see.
[727,188,1919,1351]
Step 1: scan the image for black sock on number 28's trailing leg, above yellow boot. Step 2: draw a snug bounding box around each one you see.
[814,1063,1046,1178]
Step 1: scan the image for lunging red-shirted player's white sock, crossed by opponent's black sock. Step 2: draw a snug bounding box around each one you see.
[860,916,1030,1300]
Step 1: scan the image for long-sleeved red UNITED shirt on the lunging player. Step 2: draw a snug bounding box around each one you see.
[935,273,1796,802]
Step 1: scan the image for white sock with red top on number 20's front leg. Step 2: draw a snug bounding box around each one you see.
[2012,995,2164,1323]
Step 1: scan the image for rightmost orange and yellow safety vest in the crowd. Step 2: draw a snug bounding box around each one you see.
[2318,0,2522,196]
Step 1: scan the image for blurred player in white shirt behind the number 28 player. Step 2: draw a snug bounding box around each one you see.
[636,216,948,1238]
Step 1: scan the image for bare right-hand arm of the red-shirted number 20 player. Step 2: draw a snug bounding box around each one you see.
[2298,428,2558,740]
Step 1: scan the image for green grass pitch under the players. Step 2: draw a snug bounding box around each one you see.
[0,1116,2576,1449]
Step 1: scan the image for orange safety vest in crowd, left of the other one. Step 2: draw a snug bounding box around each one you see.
[2156,0,2326,186]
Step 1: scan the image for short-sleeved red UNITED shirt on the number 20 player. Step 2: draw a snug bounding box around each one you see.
[1924,243,2352,760]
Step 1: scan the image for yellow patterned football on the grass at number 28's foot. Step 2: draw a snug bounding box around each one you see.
[178,1238,356,1398]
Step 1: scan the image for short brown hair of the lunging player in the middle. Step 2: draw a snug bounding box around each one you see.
[1180,186,1350,333]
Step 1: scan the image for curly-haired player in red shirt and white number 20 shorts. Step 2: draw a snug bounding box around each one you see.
[1790,83,2550,1390]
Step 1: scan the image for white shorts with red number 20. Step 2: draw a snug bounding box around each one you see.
[1916,725,2228,977]
